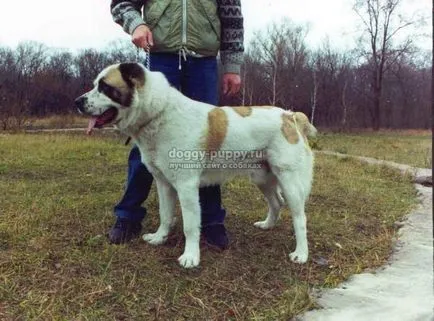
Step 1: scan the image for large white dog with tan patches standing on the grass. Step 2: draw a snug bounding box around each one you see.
[75,63,316,268]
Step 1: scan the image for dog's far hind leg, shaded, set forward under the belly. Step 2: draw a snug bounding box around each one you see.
[253,177,283,230]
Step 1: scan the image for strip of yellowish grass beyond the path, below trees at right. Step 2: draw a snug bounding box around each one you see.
[318,131,432,168]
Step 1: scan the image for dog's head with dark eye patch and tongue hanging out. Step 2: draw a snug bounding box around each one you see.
[75,63,145,133]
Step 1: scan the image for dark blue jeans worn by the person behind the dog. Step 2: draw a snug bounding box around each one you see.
[114,54,226,227]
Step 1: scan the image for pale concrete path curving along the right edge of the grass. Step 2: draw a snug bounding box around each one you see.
[296,152,434,321]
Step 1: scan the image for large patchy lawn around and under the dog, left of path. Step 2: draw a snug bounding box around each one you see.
[0,134,415,320]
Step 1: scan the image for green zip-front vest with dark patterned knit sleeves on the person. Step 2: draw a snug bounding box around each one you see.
[111,0,244,73]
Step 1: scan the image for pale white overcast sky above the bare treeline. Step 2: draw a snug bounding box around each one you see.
[0,0,432,49]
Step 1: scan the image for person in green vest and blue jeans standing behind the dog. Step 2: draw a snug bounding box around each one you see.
[109,0,244,249]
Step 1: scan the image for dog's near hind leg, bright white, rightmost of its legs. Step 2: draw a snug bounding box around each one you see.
[277,170,309,263]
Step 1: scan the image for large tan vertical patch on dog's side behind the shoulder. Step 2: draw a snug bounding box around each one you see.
[206,107,228,151]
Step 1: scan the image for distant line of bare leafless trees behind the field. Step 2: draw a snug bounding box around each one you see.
[0,21,432,130]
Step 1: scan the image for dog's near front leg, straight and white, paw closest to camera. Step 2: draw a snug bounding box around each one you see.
[177,183,201,268]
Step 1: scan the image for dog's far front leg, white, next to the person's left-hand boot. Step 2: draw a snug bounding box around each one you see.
[143,177,176,245]
